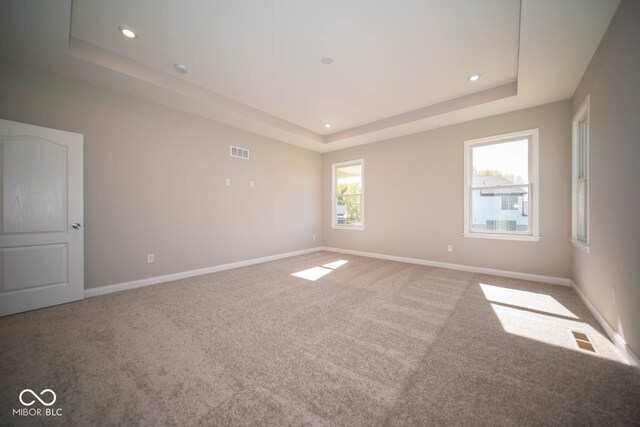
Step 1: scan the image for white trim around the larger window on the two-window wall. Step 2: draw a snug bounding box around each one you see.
[463,129,540,242]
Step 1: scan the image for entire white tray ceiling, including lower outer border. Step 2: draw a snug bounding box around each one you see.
[0,0,619,152]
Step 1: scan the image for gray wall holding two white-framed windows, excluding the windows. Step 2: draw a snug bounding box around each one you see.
[322,101,571,278]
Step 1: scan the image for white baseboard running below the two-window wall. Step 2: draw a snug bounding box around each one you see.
[321,247,571,286]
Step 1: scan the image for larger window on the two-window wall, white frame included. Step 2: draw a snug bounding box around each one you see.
[464,129,540,241]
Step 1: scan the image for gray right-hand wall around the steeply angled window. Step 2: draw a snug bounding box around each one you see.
[572,1,640,355]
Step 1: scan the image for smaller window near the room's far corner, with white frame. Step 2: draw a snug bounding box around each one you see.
[331,160,364,230]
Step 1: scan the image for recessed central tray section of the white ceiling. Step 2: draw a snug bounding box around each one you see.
[71,0,520,134]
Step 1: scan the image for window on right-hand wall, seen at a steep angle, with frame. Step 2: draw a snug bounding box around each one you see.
[571,96,590,252]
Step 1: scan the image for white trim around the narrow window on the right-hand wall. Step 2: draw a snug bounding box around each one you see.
[571,95,591,253]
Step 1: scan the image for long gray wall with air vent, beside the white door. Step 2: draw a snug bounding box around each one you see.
[0,58,322,288]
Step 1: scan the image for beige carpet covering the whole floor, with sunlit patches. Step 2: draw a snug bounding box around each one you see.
[0,252,640,426]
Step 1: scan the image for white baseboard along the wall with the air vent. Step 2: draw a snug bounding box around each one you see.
[84,247,322,298]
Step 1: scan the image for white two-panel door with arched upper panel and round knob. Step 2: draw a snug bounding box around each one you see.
[0,120,84,316]
